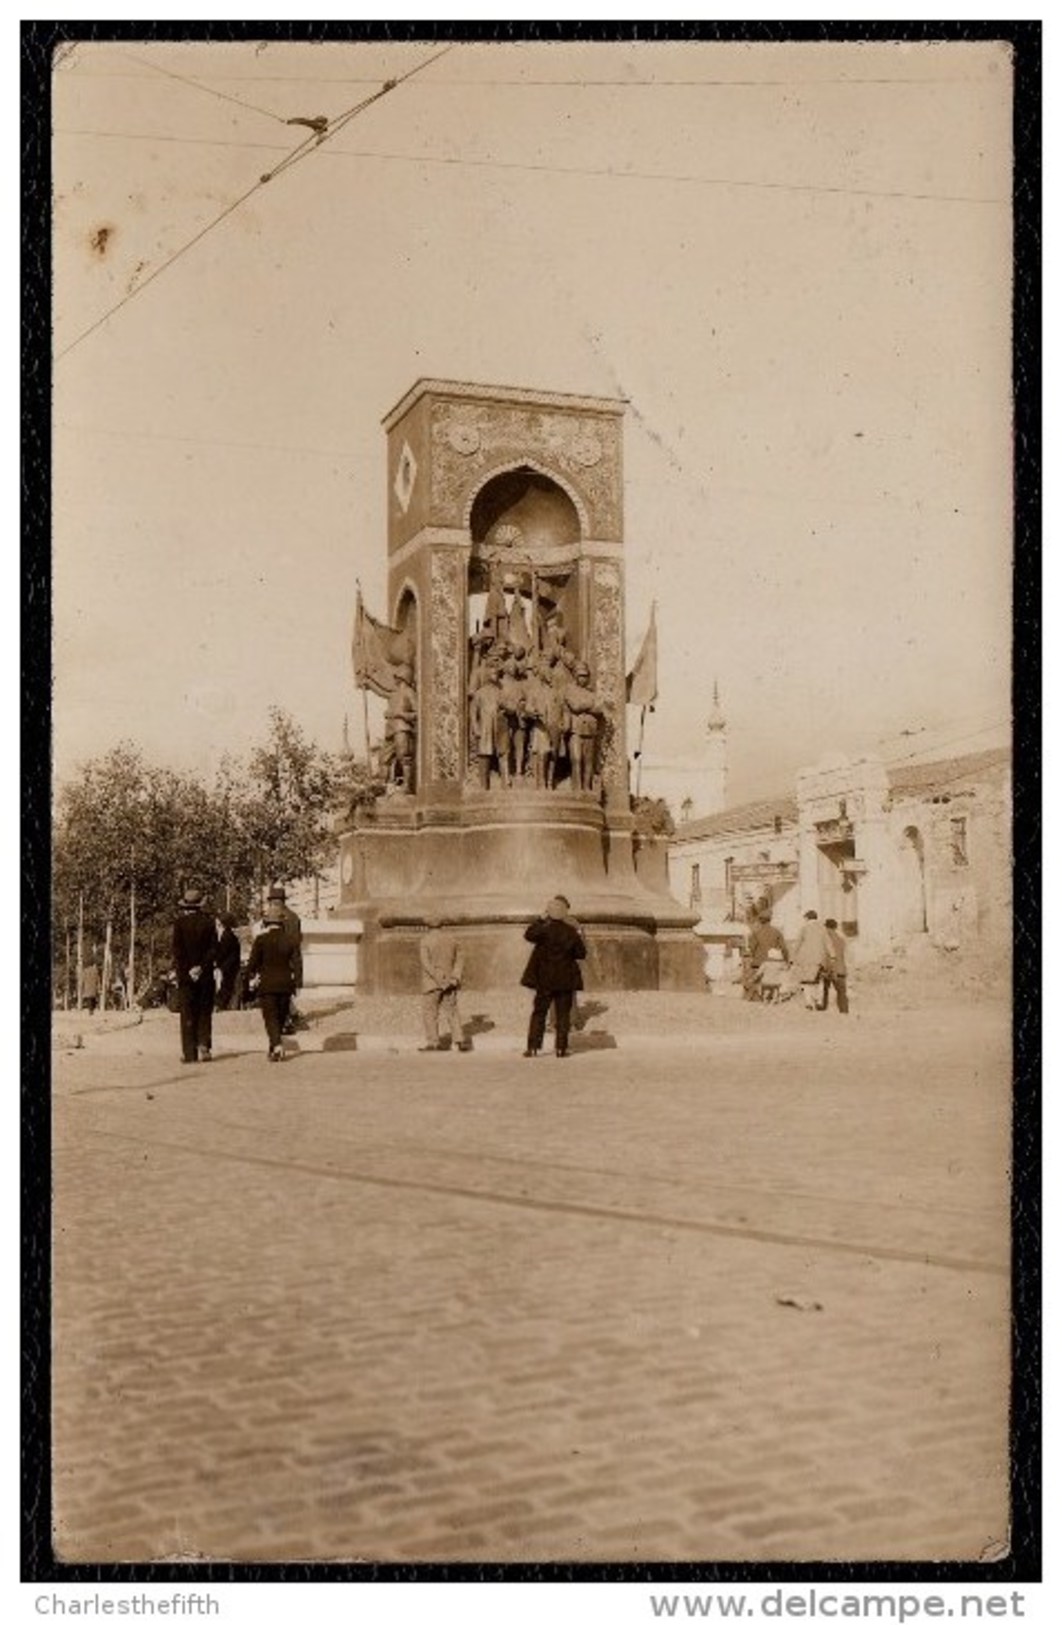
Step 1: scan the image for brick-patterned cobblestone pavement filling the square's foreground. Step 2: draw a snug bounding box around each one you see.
[54,1006,1008,1563]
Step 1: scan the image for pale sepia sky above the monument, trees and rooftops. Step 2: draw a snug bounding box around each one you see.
[54,42,1012,801]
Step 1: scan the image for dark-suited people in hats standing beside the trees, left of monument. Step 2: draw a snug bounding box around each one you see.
[174,886,302,1064]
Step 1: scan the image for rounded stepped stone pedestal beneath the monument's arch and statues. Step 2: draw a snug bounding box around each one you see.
[336,788,703,993]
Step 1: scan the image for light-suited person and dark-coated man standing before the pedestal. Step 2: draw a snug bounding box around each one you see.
[421,894,586,1060]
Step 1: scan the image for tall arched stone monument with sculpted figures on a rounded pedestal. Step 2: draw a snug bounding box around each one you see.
[336,379,703,991]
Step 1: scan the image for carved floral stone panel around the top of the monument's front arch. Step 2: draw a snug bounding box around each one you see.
[432,401,622,536]
